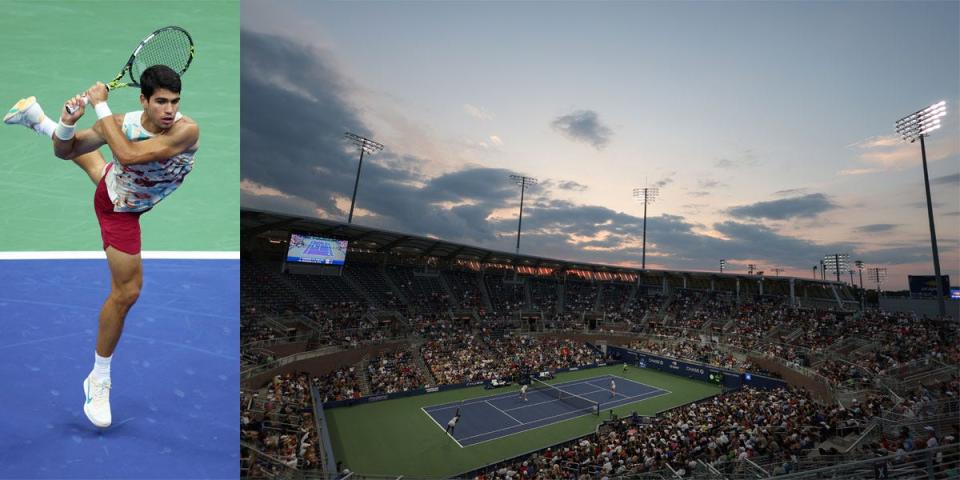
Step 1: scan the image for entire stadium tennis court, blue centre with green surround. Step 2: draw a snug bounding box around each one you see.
[324,365,720,478]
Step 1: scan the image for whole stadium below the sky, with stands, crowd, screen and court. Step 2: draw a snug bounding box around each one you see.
[240,210,960,479]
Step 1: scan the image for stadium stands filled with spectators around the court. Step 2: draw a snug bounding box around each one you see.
[241,213,960,479]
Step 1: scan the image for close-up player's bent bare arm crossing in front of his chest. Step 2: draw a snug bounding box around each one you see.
[87,82,200,165]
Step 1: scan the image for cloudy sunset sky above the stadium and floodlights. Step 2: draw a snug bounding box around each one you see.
[241,1,960,288]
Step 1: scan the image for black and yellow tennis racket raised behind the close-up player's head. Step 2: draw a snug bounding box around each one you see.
[67,26,195,113]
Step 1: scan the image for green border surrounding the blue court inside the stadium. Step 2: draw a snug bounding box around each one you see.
[325,365,720,477]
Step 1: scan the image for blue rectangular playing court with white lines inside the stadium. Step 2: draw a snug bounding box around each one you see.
[422,375,670,447]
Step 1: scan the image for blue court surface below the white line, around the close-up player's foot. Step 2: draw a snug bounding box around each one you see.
[0,260,240,478]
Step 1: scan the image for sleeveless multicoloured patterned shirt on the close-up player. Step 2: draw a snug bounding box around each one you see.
[105,110,196,212]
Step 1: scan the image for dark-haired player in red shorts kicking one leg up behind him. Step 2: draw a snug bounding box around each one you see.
[4,65,200,428]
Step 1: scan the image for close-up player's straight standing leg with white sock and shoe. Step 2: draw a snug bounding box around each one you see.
[83,246,143,428]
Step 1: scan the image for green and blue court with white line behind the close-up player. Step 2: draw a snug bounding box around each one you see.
[0,0,240,478]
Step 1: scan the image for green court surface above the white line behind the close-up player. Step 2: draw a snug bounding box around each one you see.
[0,0,240,252]
